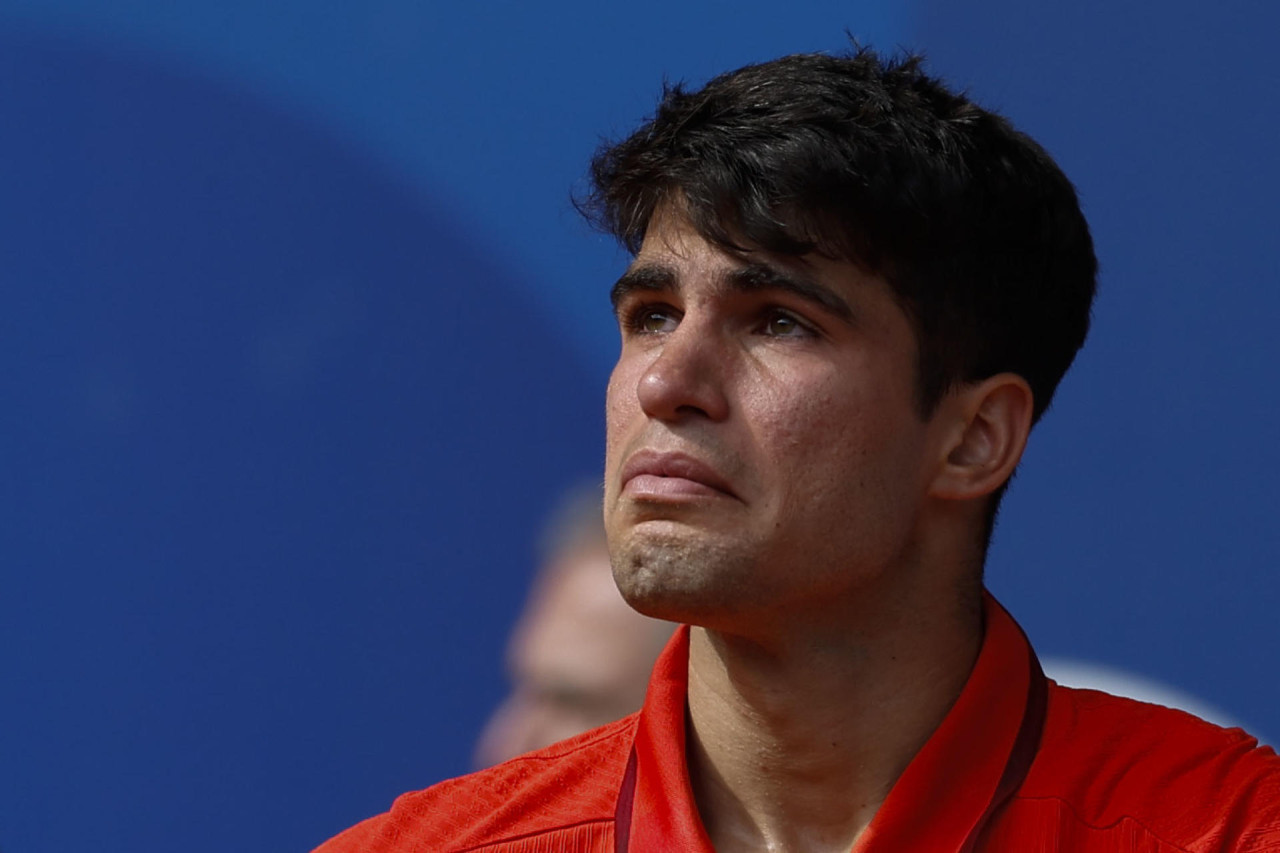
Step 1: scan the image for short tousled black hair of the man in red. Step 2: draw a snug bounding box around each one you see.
[579,47,1097,420]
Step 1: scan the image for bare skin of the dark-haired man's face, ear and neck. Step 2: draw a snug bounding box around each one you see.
[604,204,1032,853]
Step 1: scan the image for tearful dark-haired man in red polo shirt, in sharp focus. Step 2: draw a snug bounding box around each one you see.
[312,50,1280,853]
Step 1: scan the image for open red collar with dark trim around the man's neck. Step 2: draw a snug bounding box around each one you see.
[616,594,1046,853]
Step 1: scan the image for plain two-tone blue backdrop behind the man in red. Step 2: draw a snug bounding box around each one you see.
[0,0,1280,853]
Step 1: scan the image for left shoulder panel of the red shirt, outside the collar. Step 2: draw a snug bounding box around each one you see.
[316,715,636,853]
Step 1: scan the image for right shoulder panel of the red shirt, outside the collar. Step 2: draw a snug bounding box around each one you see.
[1016,683,1280,852]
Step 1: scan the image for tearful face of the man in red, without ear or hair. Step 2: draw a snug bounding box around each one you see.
[604,209,957,629]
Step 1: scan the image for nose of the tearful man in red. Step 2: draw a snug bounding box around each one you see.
[636,316,730,421]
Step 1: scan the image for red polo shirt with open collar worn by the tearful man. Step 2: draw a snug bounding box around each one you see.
[317,596,1280,853]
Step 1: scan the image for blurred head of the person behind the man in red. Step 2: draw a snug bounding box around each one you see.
[475,485,672,767]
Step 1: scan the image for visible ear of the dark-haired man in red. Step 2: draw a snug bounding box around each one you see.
[929,373,1033,501]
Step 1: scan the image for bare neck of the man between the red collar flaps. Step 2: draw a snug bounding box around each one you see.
[687,581,982,853]
